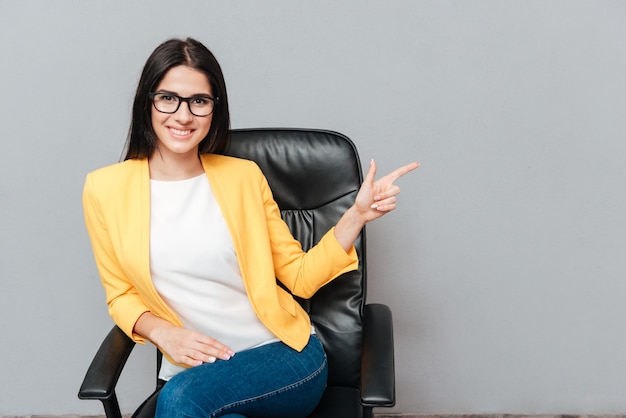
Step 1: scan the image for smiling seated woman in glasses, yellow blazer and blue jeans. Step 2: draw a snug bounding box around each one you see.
[83,39,418,417]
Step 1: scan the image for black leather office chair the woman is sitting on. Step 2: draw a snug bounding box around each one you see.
[78,129,395,418]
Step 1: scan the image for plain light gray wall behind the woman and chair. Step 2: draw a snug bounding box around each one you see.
[0,0,626,415]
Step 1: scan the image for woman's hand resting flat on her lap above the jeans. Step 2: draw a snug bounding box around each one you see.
[134,312,235,367]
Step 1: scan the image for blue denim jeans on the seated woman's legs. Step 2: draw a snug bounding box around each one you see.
[156,335,328,418]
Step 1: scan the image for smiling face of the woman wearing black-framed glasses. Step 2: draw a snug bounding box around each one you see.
[152,65,214,158]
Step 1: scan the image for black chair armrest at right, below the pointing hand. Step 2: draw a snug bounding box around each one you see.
[361,304,396,407]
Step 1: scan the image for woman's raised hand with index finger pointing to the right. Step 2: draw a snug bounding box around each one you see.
[354,160,419,224]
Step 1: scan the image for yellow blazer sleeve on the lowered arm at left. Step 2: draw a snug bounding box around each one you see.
[83,174,150,343]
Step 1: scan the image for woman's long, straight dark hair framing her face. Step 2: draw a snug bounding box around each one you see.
[124,38,230,160]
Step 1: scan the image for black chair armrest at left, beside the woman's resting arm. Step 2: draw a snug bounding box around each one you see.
[78,326,135,417]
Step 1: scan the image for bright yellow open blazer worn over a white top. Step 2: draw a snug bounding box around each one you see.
[83,154,358,360]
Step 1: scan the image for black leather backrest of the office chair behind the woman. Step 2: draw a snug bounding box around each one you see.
[225,129,366,388]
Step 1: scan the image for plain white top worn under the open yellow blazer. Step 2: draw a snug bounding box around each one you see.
[150,173,277,380]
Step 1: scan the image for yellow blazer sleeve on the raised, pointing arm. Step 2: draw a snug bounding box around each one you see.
[260,168,358,298]
